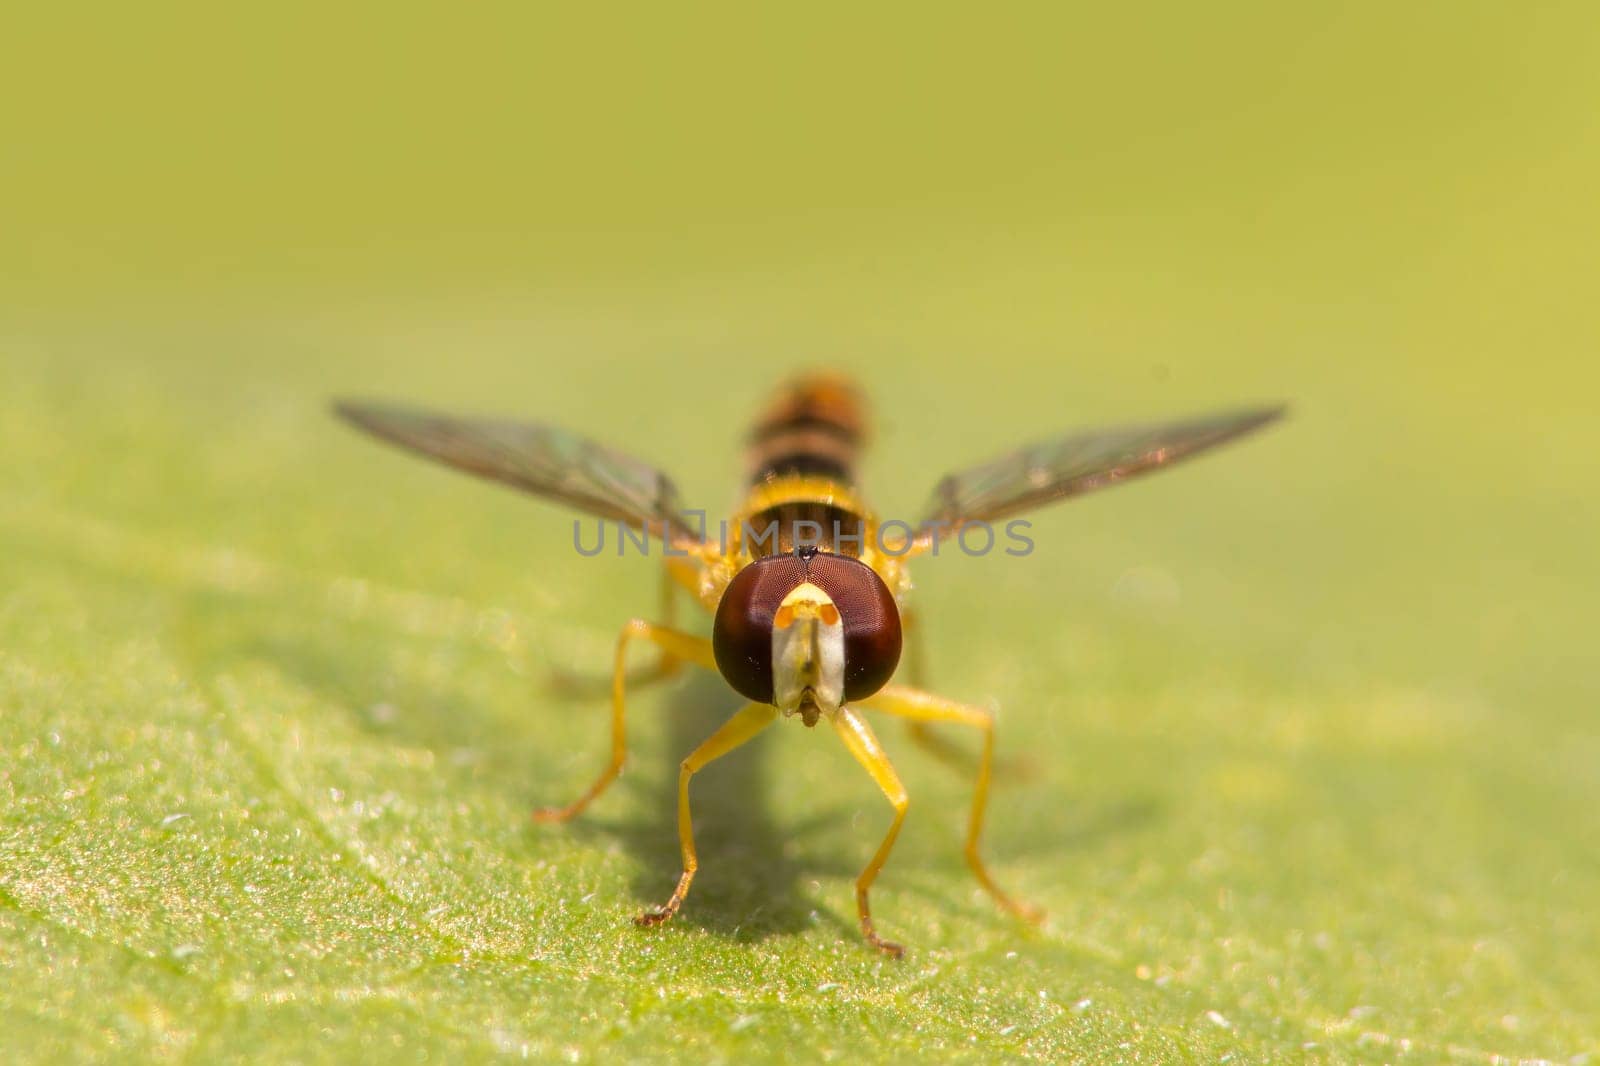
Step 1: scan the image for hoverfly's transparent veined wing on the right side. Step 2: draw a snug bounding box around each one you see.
[918,407,1285,541]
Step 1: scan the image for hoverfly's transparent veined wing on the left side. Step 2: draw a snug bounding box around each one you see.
[333,400,701,543]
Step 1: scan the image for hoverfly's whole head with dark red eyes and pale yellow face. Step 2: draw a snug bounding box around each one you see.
[712,551,901,725]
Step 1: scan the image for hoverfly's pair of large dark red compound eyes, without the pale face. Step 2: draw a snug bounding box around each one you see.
[712,552,901,703]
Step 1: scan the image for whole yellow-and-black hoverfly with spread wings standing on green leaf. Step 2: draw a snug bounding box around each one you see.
[336,375,1283,957]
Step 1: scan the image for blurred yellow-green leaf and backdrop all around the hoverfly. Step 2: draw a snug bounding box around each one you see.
[0,3,1600,1063]
